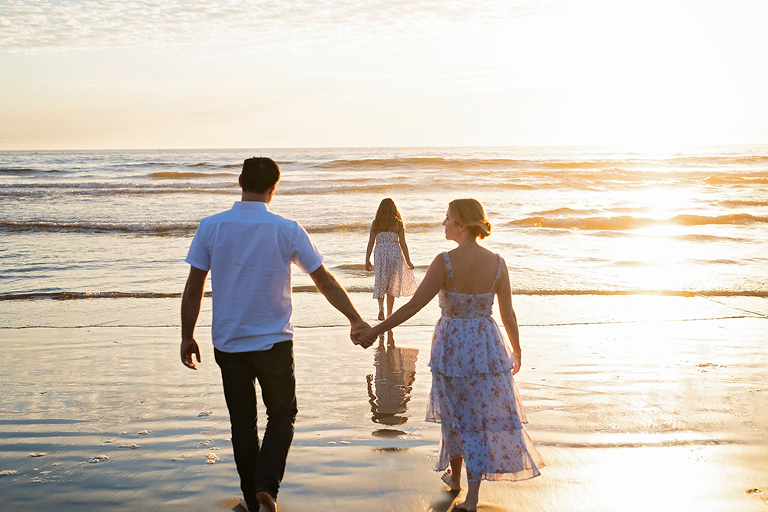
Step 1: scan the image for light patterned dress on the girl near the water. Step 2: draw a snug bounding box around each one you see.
[373,231,416,299]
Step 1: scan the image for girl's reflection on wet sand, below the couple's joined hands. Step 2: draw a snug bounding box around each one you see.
[366,331,419,437]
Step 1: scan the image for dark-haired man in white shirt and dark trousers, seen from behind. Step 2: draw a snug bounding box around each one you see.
[181,158,371,512]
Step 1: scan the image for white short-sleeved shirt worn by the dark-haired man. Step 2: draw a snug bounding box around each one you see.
[186,201,323,352]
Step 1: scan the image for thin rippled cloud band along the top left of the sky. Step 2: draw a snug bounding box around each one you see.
[0,0,551,52]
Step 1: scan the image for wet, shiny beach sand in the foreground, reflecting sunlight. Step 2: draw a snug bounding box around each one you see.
[0,294,768,512]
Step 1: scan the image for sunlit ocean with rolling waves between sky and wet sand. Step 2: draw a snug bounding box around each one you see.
[0,146,768,327]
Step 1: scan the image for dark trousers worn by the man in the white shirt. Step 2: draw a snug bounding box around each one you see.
[214,340,298,511]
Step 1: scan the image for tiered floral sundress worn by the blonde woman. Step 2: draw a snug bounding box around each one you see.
[426,253,544,482]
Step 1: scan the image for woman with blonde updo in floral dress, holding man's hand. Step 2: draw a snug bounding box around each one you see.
[356,199,544,511]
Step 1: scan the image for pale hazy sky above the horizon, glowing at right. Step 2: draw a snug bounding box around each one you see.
[0,0,768,150]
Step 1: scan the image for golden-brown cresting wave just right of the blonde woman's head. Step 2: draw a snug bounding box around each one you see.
[507,213,768,231]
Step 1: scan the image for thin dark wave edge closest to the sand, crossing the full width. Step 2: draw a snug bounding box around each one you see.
[0,285,768,302]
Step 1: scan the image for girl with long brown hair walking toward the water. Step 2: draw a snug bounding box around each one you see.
[365,198,416,320]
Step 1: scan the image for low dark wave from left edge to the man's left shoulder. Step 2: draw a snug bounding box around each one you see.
[0,221,198,236]
